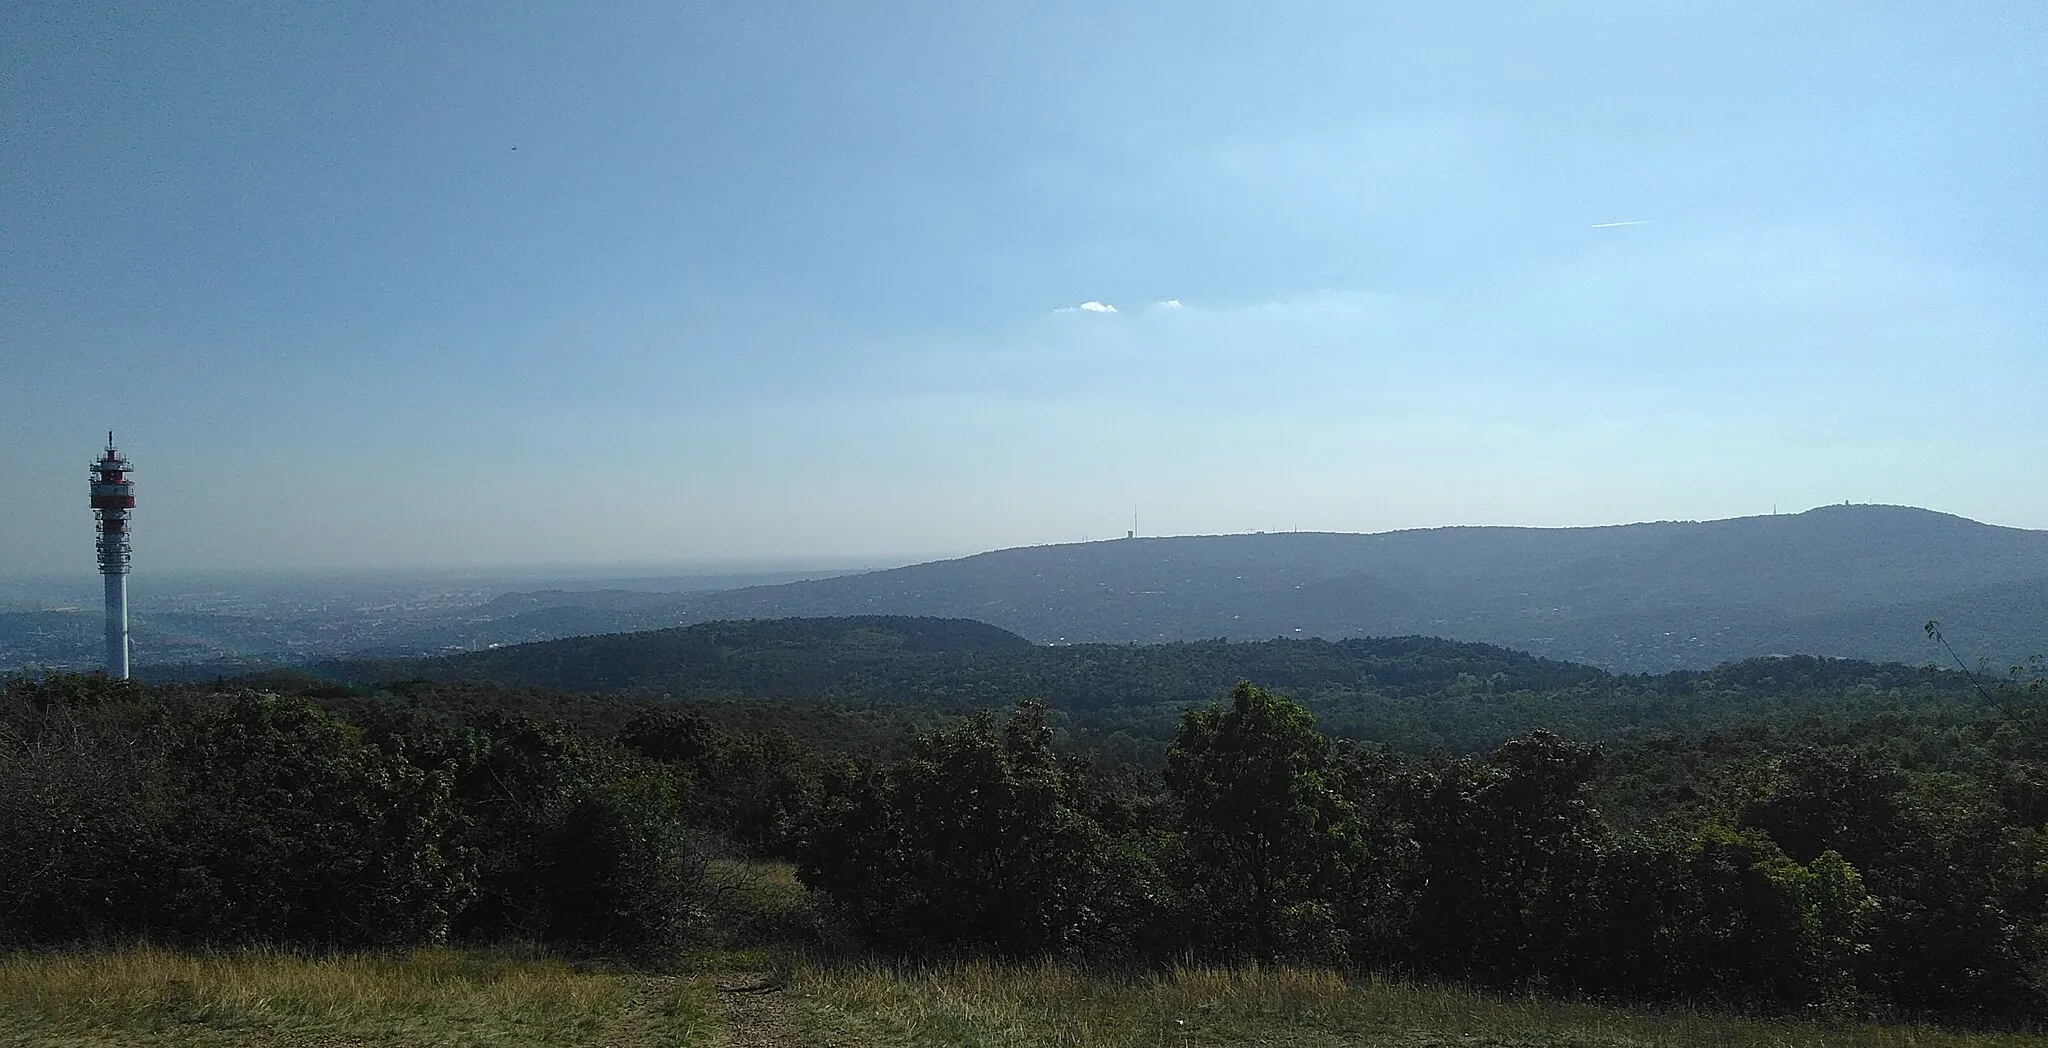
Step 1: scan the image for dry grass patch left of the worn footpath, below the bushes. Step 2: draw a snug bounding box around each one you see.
[0,948,711,1046]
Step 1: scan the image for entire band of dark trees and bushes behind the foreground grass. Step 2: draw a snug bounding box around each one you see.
[0,675,2048,1023]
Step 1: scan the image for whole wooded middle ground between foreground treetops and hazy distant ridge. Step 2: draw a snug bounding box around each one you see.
[326,616,1980,755]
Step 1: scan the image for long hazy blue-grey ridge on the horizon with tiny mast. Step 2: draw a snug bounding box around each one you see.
[483,506,2048,671]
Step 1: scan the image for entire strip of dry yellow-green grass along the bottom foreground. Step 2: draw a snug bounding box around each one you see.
[0,950,2048,1048]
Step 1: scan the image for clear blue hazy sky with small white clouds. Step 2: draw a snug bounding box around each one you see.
[0,0,2048,573]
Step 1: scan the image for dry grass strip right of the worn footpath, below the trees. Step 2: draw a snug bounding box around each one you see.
[793,964,2044,1048]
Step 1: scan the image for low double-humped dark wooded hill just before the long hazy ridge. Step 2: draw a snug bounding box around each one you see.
[339,616,1608,708]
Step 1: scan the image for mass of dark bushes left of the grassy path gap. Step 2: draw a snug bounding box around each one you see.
[0,675,700,958]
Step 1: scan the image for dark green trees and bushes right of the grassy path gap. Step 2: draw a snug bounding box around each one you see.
[803,684,2048,1017]
